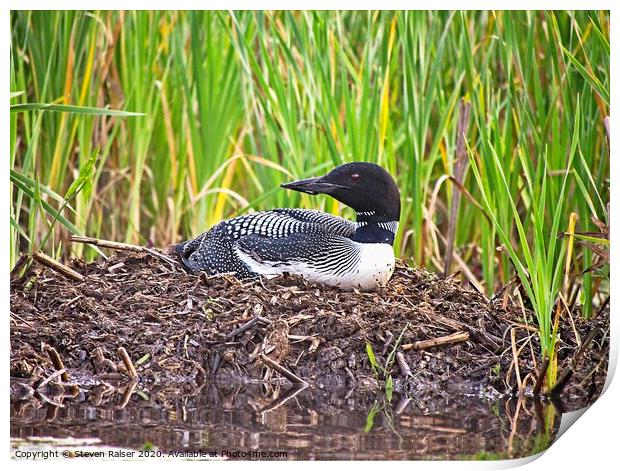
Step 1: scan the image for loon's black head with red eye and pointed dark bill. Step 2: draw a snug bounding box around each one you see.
[281,162,400,221]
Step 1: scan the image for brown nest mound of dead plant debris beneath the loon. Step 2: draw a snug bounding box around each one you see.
[10,252,609,405]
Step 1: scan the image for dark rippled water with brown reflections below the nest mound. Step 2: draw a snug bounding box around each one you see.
[11,385,559,460]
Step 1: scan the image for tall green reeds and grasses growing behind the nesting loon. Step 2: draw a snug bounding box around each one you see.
[10,11,610,381]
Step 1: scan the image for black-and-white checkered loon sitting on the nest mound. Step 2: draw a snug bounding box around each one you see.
[174,162,400,291]
